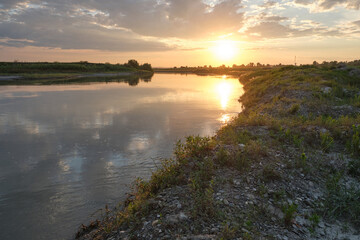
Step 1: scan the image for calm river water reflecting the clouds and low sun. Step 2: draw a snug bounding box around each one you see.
[0,74,243,240]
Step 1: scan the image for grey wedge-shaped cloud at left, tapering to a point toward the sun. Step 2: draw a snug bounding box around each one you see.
[0,6,171,51]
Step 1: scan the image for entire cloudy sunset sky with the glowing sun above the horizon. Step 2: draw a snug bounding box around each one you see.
[0,0,360,67]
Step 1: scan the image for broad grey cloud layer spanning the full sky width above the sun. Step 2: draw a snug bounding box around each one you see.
[0,0,360,51]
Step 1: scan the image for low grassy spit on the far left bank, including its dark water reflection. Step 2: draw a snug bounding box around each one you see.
[0,60,153,85]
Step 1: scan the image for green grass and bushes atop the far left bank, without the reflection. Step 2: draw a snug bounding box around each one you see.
[0,59,153,74]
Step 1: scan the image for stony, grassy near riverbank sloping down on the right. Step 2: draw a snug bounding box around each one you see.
[77,64,360,239]
